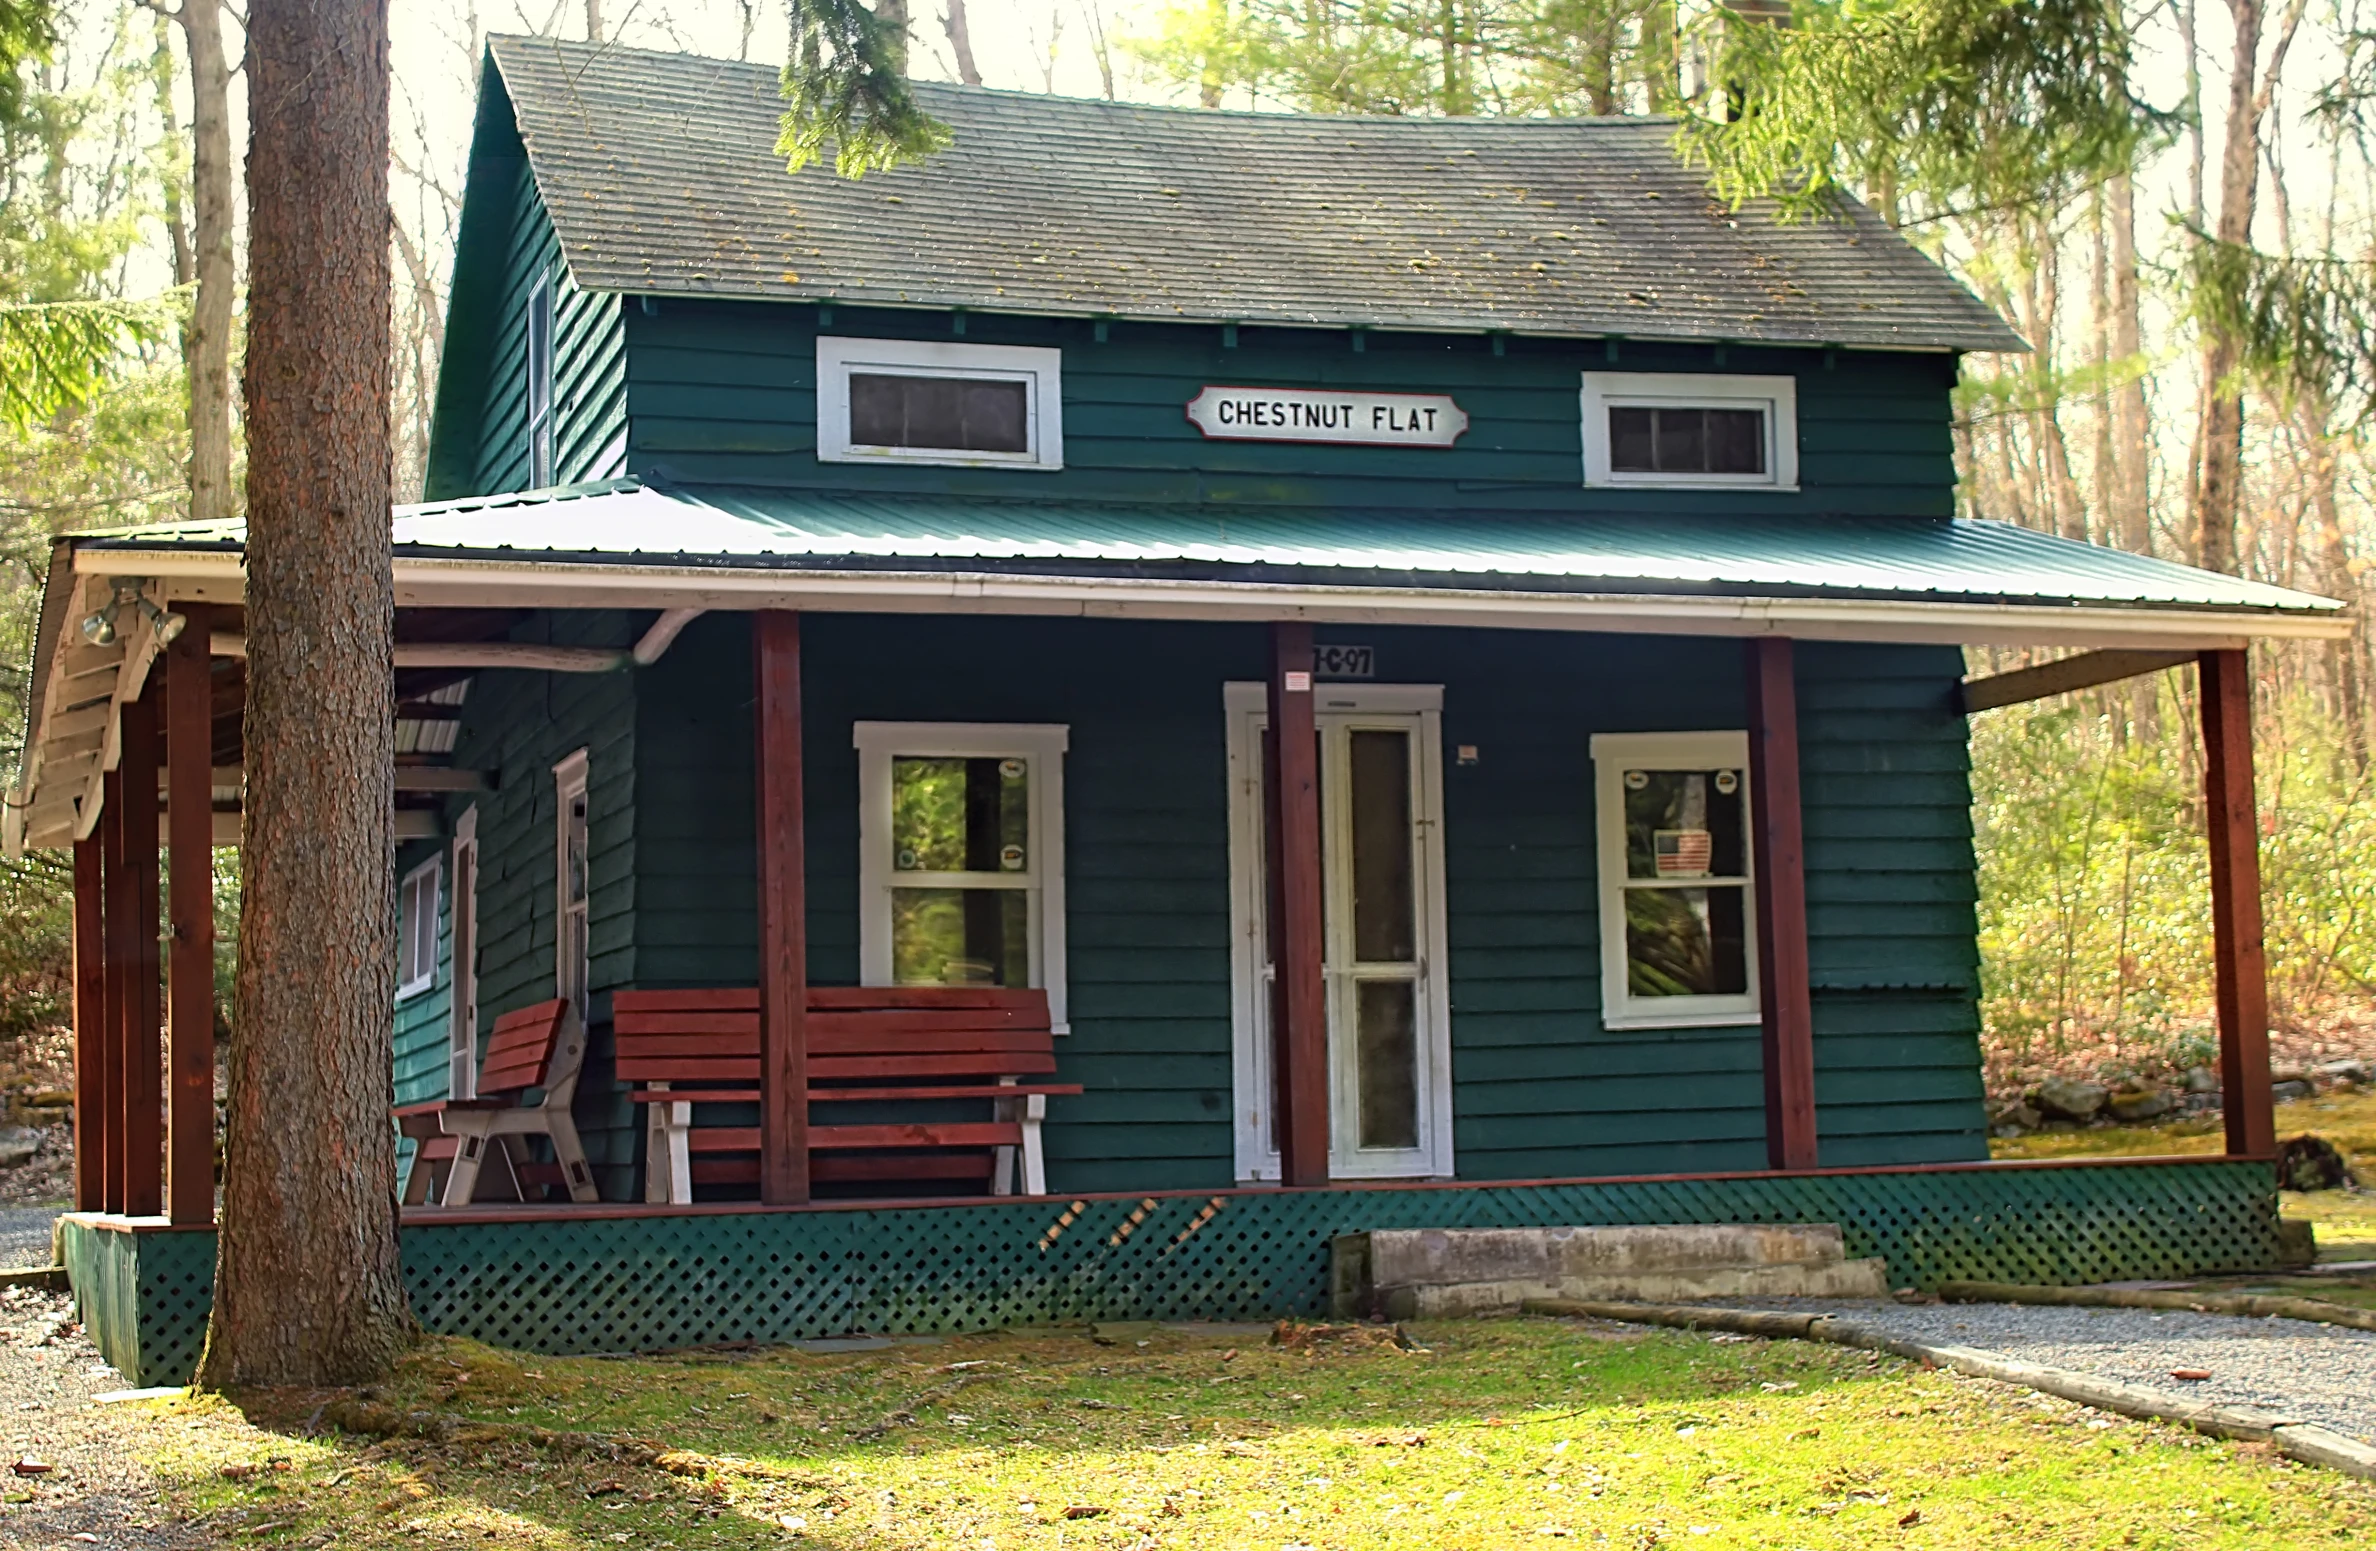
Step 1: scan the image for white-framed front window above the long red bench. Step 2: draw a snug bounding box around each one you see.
[851,722,1067,1033]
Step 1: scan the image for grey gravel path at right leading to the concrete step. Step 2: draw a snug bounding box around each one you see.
[1742,1299,2376,1444]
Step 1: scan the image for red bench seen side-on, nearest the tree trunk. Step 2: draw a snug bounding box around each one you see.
[397,1000,596,1207]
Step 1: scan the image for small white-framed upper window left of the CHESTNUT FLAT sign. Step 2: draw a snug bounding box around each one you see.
[817,335,1064,468]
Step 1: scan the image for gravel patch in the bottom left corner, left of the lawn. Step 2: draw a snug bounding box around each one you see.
[0,1287,214,1551]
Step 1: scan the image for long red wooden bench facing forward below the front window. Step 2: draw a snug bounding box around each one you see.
[611,986,1081,1202]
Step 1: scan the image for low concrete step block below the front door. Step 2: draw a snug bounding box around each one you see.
[1328,1223,1889,1318]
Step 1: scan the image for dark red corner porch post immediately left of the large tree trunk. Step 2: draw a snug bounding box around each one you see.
[164,603,214,1228]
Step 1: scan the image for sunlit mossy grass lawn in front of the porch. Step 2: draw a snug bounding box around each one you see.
[115,1321,2376,1551]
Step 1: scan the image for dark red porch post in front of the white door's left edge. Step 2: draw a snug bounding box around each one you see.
[1264,622,1328,1185]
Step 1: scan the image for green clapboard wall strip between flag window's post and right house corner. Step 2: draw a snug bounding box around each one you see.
[1799,644,1989,1166]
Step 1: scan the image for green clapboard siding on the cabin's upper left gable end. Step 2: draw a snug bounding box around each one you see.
[423,71,627,501]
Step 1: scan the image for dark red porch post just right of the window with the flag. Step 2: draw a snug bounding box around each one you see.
[1746,637,1815,1169]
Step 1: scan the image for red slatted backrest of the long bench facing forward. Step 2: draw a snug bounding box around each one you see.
[611,986,1055,1088]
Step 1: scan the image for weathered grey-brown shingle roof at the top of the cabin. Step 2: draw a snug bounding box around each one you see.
[489,38,2024,349]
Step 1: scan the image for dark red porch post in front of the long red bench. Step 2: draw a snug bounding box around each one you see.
[751,610,808,1207]
